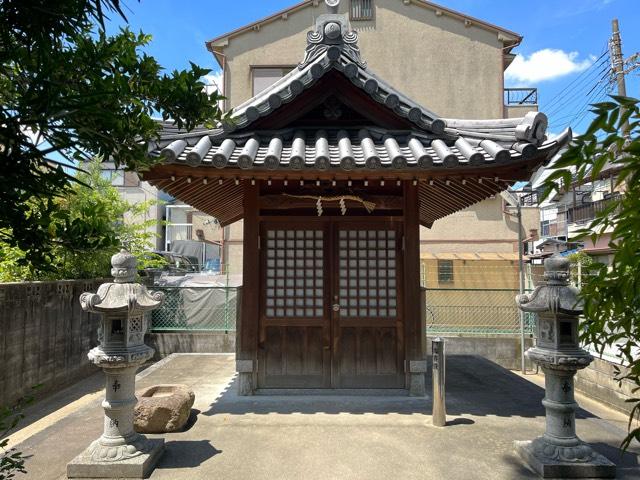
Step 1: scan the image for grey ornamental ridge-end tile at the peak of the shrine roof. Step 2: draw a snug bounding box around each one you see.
[298,0,367,70]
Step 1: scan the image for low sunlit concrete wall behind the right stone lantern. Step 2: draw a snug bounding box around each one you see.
[575,358,637,413]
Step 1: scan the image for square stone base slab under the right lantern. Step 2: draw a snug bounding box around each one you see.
[515,437,616,478]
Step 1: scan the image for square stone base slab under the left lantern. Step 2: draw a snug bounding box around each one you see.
[67,437,164,478]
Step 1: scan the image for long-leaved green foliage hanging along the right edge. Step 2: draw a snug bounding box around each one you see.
[546,97,640,449]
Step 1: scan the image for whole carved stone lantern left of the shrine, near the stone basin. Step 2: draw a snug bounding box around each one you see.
[67,250,164,478]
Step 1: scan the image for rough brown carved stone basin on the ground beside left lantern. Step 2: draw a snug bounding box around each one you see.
[134,384,195,433]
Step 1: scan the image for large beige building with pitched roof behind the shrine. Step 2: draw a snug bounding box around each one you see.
[207,0,538,273]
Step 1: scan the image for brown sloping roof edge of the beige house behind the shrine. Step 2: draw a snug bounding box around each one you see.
[205,0,523,65]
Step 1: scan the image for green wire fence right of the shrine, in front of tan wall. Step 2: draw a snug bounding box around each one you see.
[425,288,535,335]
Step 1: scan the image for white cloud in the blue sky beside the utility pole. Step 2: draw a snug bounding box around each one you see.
[504,48,596,85]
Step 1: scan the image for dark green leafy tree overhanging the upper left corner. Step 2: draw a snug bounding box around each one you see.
[0,0,221,268]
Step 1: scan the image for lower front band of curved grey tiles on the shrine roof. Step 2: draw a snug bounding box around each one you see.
[154,124,570,170]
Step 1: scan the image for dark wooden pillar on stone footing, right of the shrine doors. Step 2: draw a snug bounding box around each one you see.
[403,181,427,396]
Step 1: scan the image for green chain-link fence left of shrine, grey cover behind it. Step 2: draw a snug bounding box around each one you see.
[151,287,240,332]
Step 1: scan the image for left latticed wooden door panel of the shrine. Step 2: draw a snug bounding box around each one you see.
[259,224,330,388]
